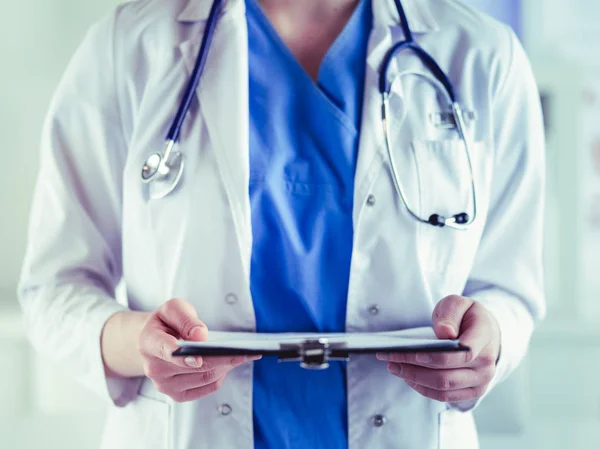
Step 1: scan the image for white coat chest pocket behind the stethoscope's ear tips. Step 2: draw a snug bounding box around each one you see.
[413,139,493,274]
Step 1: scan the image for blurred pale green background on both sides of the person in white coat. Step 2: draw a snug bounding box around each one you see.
[0,0,600,449]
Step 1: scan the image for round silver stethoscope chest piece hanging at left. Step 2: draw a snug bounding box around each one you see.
[142,151,185,200]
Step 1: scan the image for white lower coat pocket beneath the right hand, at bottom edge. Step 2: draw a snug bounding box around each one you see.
[438,409,479,449]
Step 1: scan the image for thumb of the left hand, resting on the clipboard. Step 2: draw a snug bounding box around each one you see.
[158,299,208,341]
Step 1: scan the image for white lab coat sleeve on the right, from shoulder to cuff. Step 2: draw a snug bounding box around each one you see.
[462,26,545,408]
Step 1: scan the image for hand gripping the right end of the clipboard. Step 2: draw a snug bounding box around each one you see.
[377,296,500,402]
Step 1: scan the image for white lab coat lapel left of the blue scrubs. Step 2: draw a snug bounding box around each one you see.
[180,1,251,274]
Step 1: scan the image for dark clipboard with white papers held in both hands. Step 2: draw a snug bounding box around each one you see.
[173,328,469,370]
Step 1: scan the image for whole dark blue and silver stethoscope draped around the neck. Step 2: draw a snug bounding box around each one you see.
[142,0,477,230]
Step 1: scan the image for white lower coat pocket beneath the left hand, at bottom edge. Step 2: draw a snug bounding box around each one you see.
[101,394,171,449]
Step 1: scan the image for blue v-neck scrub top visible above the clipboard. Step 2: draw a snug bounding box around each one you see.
[247,0,372,332]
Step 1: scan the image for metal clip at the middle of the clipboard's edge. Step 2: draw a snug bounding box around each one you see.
[279,338,348,370]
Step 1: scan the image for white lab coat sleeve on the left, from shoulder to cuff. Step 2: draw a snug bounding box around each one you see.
[19,7,140,405]
